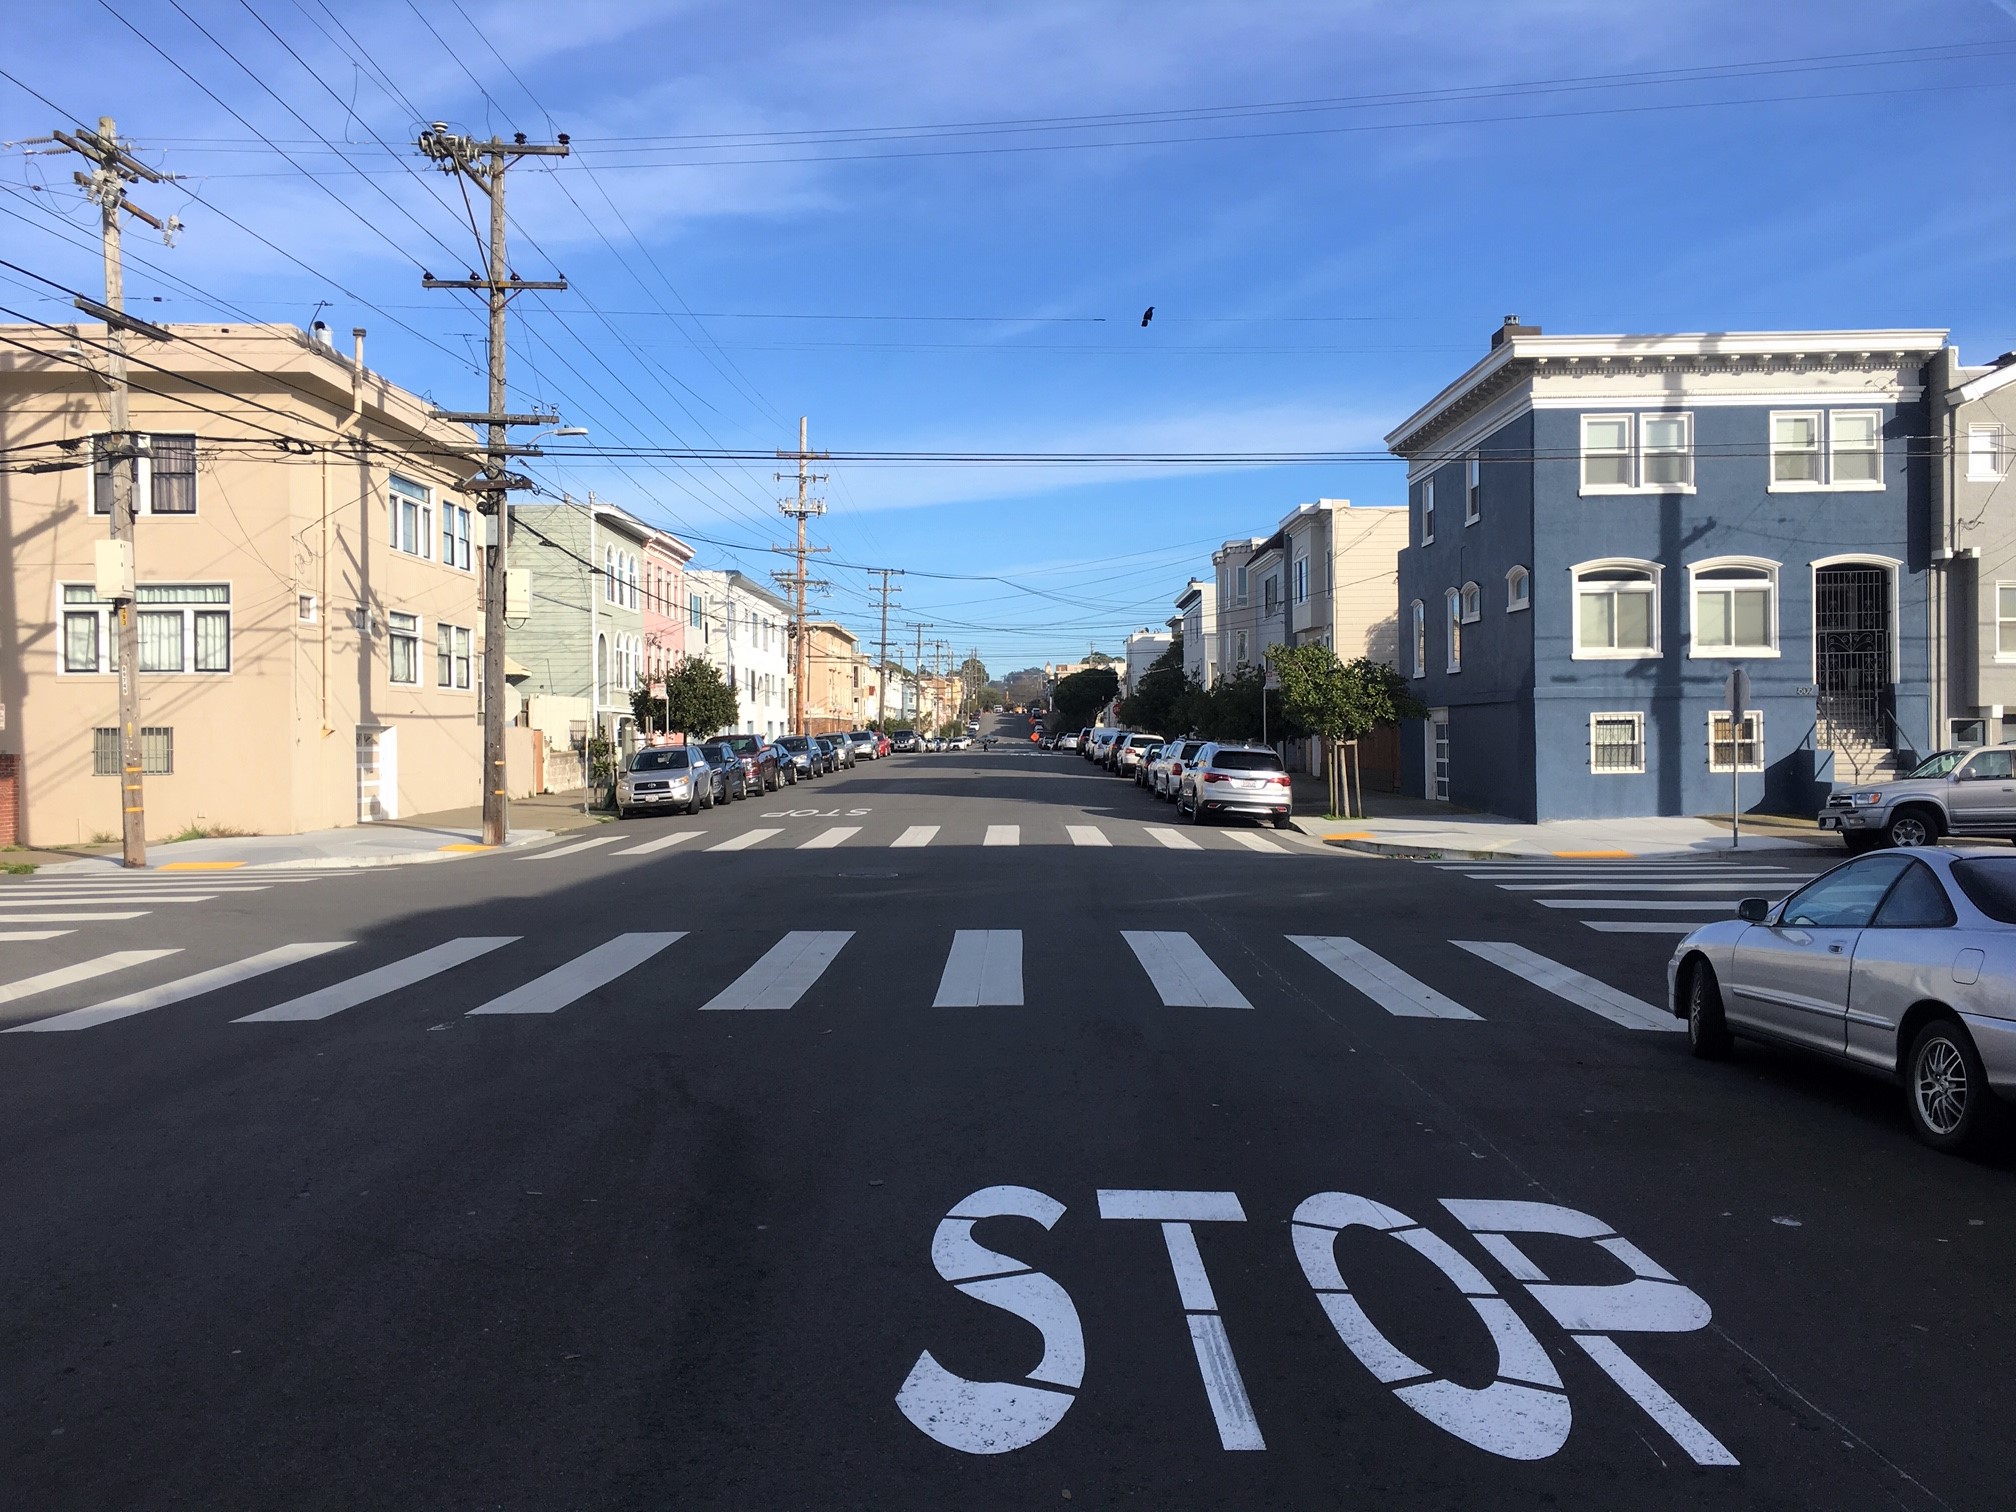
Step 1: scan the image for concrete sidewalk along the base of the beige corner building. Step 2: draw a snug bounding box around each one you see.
[23,792,609,877]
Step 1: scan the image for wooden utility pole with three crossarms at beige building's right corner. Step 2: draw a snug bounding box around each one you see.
[419,121,572,845]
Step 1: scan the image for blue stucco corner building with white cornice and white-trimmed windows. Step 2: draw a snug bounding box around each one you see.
[1387,319,1945,821]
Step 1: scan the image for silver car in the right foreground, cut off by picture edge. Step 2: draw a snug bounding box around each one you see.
[1665,849,2016,1149]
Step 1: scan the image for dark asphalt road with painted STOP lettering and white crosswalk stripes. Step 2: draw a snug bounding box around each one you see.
[0,713,2016,1508]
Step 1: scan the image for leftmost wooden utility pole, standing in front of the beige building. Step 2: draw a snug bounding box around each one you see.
[34,115,181,867]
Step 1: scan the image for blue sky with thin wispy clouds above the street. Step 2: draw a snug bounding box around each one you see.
[0,0,2016,671]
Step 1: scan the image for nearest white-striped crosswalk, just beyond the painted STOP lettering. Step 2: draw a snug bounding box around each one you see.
[0,929,1679,1034]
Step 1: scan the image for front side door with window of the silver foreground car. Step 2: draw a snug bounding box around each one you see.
[1726,855,1913,1054]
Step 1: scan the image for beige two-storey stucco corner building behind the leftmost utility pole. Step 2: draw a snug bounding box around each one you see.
[0,325,486,845]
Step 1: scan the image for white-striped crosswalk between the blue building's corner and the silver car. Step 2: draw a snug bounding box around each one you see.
[1427,853,1833,935]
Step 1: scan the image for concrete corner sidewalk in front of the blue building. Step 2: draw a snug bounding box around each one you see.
[1294,776,1841,861]
